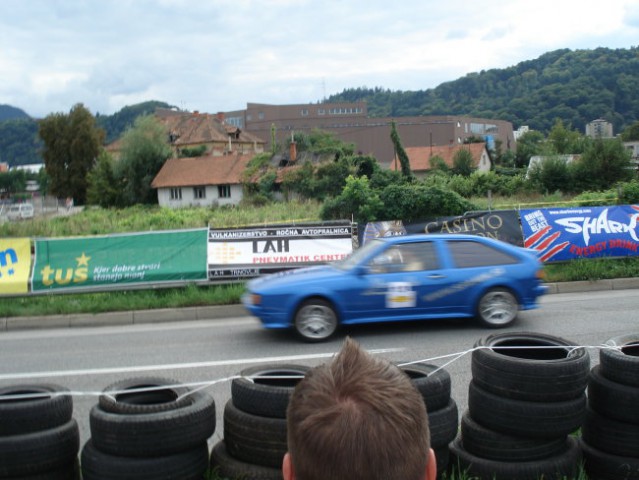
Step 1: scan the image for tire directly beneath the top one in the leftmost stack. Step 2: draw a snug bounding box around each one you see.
[0,419,80,478]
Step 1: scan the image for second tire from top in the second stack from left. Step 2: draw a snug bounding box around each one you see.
[89,391,215,457]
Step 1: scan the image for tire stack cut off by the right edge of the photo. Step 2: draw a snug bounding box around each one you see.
[581,334,639,480]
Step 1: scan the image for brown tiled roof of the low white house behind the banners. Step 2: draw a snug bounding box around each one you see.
[151,155,254,188]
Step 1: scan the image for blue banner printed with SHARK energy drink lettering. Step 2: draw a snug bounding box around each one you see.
[519,205,639,262]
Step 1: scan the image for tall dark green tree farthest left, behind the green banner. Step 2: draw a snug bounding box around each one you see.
[39,103,104,205]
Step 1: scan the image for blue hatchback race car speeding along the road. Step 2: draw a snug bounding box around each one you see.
[242,235,548,342]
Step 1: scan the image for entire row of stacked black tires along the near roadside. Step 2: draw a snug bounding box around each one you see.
[6,332,639,480]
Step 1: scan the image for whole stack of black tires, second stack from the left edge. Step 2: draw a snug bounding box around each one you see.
[80,377,216,480]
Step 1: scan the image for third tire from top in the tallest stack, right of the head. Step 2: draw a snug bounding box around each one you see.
[461,411,566,462]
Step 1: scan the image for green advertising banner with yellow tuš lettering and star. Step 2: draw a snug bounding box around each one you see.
[31,228,208,291]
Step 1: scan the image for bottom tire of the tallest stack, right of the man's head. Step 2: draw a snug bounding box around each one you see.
[450,437,581,480]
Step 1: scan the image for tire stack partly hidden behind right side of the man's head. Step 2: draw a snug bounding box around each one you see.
[398,362,459,478]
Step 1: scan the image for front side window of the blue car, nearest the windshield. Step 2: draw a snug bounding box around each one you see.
[369,242,439,273]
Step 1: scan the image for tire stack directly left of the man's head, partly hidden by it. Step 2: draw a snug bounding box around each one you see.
[210,364,309,480]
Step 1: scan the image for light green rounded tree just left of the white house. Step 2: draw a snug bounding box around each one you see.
[115,115,173,206]
